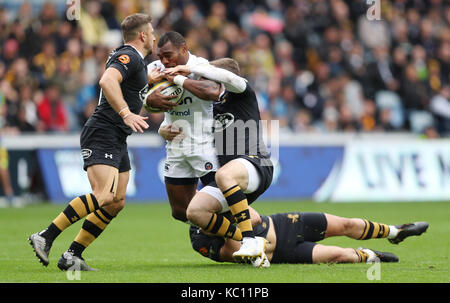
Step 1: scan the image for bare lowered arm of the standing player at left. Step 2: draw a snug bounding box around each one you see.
[99,67,148,133]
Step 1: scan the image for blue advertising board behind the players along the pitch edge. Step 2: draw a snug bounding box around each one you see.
[37,146,344,203]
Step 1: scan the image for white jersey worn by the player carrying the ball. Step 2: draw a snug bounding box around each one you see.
[147,53,214,154]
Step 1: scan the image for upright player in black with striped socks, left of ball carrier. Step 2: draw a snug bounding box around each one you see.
[29,14,155,270]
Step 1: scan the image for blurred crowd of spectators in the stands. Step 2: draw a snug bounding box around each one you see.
[0,0,450,137]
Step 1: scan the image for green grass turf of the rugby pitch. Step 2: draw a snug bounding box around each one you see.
[0,201,450,283]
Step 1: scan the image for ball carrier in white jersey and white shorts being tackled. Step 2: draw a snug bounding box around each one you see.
[146,31,220,222]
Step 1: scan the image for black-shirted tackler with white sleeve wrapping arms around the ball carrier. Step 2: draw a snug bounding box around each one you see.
[160,58,273,267]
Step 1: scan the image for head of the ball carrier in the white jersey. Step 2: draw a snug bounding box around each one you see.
[157,32,189,68]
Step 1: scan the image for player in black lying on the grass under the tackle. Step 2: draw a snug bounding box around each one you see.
[189,207,428,267]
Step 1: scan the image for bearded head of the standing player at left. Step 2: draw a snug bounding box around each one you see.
[121,14,156,55]
